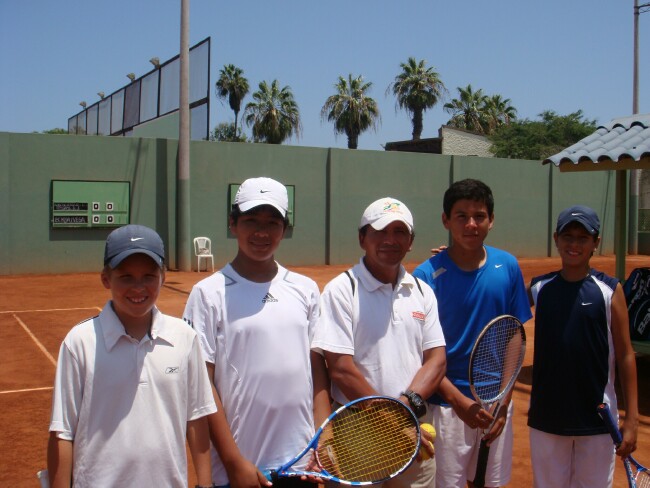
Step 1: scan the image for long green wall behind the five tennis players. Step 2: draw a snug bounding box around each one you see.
[0,133,615,275]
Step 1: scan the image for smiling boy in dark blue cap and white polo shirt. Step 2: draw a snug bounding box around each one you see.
[48,225,216,488]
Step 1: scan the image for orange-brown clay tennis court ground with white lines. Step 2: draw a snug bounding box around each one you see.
[0,256,650,488]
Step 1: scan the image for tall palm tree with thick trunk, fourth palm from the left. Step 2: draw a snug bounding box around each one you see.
[386,57,447,141]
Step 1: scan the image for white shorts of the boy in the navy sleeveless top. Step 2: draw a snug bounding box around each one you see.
[530,428,616,488]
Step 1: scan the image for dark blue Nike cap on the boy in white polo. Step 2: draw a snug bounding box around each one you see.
[104,224,165,268]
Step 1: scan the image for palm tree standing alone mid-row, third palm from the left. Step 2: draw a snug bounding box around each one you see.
[320,74,381,149]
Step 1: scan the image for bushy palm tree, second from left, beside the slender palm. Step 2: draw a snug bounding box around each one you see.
[244,80,302,144]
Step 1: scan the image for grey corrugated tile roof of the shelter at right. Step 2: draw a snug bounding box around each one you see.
[542,114,650,166]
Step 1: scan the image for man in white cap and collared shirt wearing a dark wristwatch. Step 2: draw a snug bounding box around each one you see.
[313,197,445,488]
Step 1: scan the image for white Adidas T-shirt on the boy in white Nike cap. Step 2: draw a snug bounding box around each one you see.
[183,265,320,485]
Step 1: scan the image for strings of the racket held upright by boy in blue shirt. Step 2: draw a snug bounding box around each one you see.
[470,318,526,403]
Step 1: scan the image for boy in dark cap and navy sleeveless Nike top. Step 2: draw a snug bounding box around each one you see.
[528,205,638,488]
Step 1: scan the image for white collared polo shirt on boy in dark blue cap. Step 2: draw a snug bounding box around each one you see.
[50,301,217,487]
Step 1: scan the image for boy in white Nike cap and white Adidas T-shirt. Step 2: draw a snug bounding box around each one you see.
[184,177,330,487]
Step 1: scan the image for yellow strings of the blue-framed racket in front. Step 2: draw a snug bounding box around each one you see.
[316,400,419,481]
